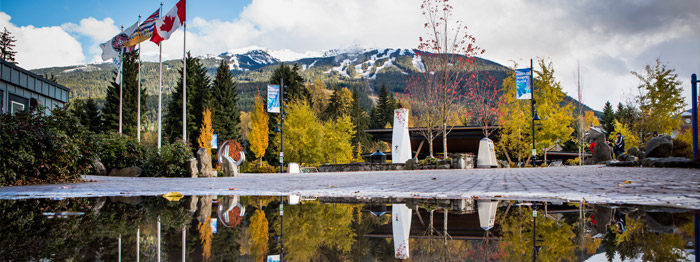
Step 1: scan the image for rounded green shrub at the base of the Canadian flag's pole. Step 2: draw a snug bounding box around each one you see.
[144,140,193,177]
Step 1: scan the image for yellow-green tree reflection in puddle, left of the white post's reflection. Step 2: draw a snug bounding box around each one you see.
[272,202,356,261]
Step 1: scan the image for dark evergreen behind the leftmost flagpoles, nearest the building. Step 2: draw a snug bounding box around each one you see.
[102,51,147,137]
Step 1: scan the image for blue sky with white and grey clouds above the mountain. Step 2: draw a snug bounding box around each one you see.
[0,0,700,110]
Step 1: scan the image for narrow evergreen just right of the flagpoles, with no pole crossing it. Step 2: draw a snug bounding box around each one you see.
[212,59,241,141]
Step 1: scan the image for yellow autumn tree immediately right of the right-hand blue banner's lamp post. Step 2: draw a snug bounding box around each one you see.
[528,59,574,161]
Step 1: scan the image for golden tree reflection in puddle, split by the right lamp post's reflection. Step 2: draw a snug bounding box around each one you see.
[501,206,575,261]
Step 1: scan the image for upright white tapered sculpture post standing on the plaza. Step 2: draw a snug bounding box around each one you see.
[391,108,411,164]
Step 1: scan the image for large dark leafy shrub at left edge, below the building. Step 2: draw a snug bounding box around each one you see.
[0,108,96,186]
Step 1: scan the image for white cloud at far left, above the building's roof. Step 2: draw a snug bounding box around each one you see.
[0,12,85,69]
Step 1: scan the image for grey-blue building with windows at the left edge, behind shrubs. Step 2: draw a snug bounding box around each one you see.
[0,59,70,114]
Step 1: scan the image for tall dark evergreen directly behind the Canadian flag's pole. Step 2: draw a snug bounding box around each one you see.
[163,52,211,146]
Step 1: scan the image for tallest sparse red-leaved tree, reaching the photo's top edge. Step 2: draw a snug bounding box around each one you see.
[407,0,484,157]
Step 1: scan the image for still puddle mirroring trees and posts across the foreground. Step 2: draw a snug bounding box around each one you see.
[0,194,695,261]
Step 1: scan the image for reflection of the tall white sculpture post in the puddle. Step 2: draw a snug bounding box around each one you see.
[391,204,413,259]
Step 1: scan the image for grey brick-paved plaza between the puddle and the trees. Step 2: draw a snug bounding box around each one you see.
[0,166,700,210]
